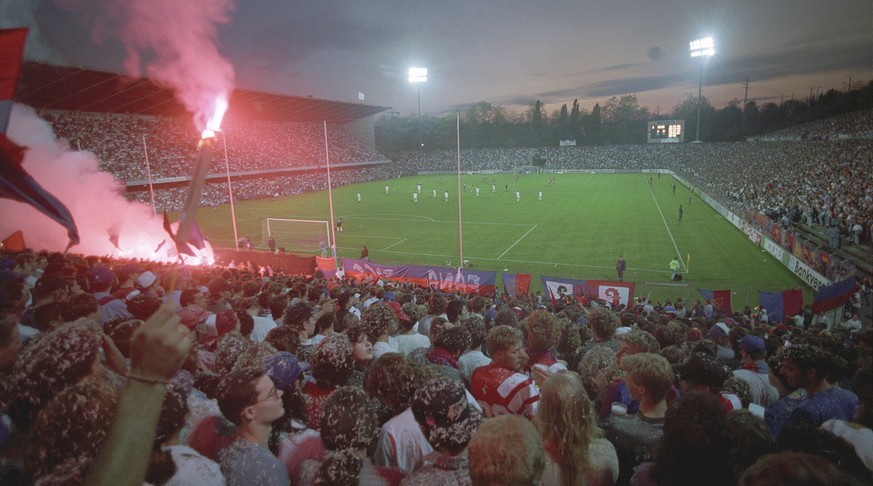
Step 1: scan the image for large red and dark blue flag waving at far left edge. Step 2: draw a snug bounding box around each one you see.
[0,29,79,248]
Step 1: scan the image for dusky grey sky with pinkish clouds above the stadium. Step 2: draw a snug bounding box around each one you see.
[6,0,873,115]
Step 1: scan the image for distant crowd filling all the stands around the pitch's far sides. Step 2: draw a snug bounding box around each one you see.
[45,108,873,258]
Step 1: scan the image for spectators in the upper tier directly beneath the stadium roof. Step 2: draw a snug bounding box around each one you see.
[43,112,384,182]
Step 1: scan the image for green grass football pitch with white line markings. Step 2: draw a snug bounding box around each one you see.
[192,174,812,308]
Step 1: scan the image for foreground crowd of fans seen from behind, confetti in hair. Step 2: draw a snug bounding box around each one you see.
[0,250,873,486]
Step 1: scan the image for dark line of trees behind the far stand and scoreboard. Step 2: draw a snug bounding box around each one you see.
[375,81,873,156]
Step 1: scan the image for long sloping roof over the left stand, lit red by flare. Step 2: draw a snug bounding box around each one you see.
[15,61,390,122]
